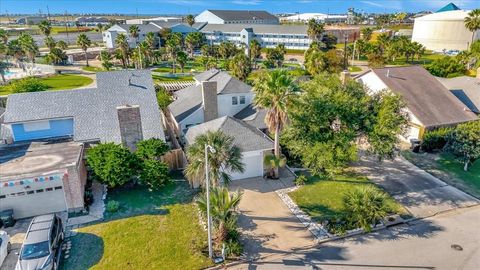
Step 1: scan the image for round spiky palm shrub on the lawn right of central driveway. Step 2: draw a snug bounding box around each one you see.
[343,186,389,232]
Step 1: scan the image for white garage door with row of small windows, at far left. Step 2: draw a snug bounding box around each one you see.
[0,175,67,218]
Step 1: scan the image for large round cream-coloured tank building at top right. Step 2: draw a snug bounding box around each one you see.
[412,7,480,51]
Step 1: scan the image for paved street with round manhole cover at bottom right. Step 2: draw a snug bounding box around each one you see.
[229,206,480,270]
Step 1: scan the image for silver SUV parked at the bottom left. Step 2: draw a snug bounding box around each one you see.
[15,214,64,270]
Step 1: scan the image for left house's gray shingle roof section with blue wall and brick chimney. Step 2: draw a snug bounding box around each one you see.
[2,70,164,148]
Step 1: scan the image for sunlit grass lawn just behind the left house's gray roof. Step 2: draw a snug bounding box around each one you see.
[0,74,93,96]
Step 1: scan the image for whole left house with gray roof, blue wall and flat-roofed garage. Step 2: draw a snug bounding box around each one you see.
[0,70,165,218]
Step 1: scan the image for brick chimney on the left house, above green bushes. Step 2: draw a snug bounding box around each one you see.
[117,105,143,151]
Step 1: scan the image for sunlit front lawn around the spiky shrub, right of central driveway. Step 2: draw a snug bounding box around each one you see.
[289,174,406,221]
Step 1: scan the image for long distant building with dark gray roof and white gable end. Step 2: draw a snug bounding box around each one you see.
[195,9,279,24]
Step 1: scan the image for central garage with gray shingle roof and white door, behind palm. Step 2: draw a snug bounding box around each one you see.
[185,116,273,180]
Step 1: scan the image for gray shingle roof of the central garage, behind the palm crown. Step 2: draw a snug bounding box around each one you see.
[185,116,273,152]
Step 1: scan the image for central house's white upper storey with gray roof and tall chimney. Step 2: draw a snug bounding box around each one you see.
[167,69,253,136]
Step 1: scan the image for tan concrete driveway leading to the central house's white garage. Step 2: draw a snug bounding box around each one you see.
[230,175,315,261]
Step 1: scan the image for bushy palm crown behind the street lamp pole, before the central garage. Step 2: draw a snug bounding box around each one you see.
[185,131,245,187]
